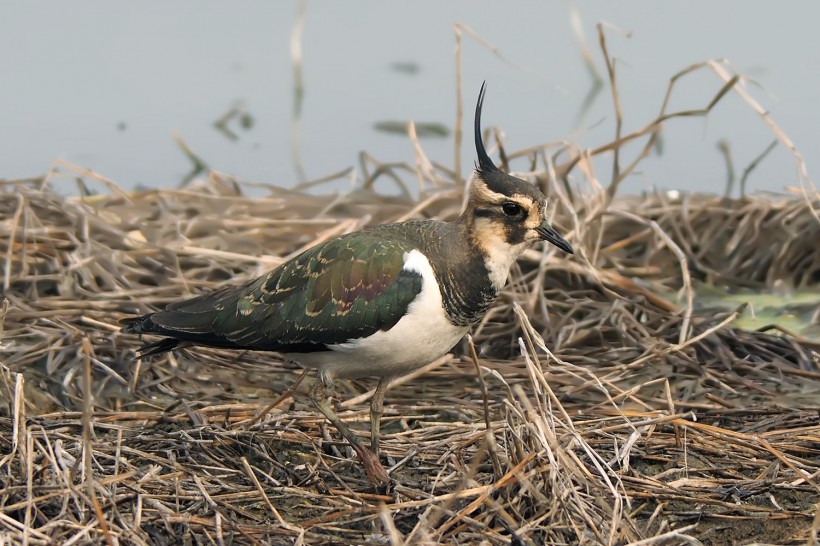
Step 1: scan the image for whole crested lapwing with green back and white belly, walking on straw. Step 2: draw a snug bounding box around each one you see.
[120,82,573,485]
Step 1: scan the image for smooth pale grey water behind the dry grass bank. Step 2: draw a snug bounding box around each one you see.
[0,0,820,193]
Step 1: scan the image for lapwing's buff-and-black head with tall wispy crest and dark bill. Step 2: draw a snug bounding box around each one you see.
[464,83,572,257]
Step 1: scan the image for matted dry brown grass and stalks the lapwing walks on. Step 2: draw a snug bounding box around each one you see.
[0,24,820,545]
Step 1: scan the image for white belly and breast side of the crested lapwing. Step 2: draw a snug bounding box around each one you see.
[287,250,469,380]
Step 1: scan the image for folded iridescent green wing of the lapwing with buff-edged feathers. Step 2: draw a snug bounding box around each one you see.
[151,232,422,351]
